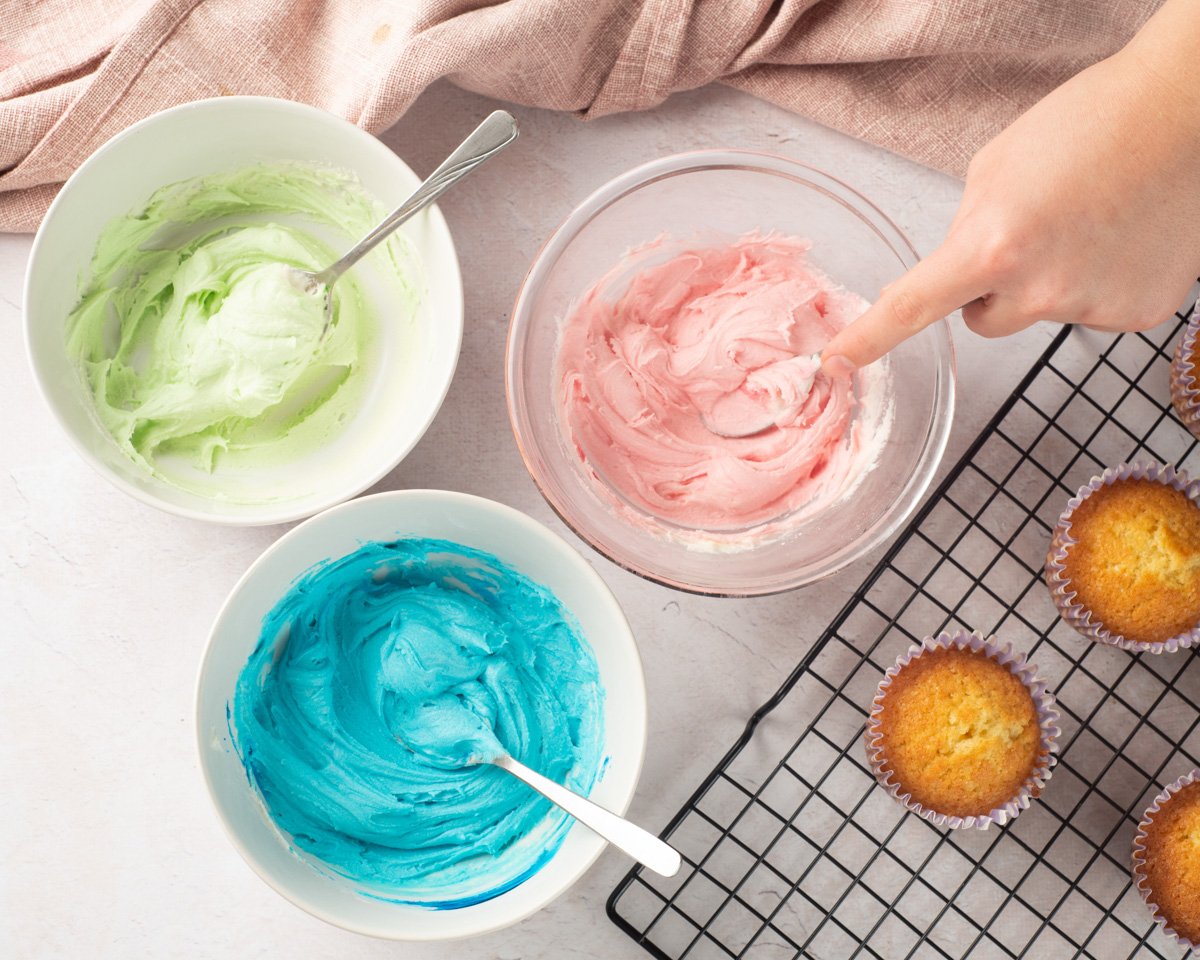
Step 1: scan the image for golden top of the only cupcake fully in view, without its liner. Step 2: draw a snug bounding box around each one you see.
[880,647,1042,817]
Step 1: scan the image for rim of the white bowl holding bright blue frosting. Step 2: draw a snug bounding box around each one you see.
[191,488,648,943]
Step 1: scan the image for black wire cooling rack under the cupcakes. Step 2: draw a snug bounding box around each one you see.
[608,297,1200,960]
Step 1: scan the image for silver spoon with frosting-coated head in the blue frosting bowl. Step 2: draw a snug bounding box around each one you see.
[397,692,683,877]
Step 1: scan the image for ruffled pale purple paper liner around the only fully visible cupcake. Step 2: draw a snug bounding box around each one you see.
[865,630,1060,830]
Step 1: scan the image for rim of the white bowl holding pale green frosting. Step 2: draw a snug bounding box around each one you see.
[22,95,466,527]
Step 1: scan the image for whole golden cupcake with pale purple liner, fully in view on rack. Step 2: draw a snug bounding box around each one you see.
[866,632,1058,829]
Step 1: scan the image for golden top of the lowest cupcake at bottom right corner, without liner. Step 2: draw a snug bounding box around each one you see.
[1140,781,1200,943]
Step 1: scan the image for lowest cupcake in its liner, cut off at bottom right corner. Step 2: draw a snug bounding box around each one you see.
[1133,770,1200,949]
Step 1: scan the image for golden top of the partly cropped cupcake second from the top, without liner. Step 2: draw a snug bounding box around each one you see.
[1063,479,1200,643]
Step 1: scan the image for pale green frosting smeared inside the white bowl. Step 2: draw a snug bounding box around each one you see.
[67,163,419,491]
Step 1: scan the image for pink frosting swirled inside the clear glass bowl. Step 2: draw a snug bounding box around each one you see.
[558,234,868,532]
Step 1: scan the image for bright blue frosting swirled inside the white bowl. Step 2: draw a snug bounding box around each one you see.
[230,539,604,907]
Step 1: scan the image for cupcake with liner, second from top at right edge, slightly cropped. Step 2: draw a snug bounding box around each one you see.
[1045,463,1200,653]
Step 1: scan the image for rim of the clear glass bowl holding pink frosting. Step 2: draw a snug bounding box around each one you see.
[504,149,956,598]
